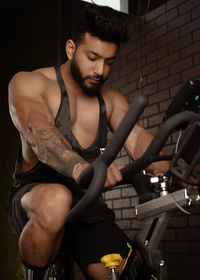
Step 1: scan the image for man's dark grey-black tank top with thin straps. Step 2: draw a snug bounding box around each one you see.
[14,66,107,192]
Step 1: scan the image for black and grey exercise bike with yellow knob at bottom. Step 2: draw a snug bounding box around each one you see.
[64,80,200,280]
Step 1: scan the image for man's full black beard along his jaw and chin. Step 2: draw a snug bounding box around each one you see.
[71,59,106,97]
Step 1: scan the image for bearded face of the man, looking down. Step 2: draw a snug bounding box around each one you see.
[71,33,118,96]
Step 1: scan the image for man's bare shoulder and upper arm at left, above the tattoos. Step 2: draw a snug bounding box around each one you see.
[9,73,54,133]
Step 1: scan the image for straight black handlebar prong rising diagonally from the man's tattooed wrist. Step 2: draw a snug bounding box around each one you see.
[78,95,147,187]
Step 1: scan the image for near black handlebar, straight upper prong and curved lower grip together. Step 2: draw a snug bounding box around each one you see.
[67,96,147,223]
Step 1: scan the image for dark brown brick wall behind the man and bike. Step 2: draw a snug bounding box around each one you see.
[105,0,200,280]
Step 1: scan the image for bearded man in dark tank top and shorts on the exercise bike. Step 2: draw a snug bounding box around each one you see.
[8,4,168,280]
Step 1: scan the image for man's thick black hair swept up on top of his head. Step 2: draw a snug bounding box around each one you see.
[72,4,129,46]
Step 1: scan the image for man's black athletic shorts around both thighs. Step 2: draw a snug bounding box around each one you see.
[8,183,129,271]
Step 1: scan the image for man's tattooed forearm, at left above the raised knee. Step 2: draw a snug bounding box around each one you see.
[31,127,85,177]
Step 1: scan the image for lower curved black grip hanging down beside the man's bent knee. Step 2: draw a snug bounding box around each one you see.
[66,162,107,223]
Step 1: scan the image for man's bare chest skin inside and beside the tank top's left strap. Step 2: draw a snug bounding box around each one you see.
[49,83,100,148]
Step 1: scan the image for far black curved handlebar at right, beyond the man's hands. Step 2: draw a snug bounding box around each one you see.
[121,111,196,180]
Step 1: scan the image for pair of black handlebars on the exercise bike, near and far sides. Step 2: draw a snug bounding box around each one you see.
[67,96,196,223]
